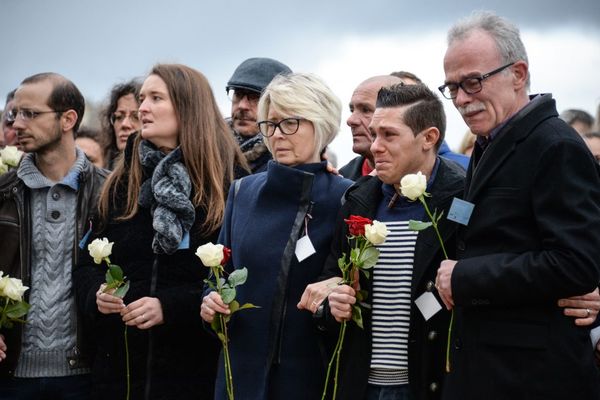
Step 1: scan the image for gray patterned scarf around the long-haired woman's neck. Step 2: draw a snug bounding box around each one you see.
[139,140,196,254]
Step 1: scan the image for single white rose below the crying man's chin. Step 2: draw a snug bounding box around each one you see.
[400,171,454,372]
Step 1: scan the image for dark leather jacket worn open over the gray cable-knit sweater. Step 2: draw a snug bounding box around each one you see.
[0,162,108,378]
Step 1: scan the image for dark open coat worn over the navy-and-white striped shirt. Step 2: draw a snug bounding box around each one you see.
[323,159,464,400]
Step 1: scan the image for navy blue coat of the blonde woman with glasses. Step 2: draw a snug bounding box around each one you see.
[216,161,352,400]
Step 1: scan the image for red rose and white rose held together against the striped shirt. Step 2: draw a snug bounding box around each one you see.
[321,215,389,400]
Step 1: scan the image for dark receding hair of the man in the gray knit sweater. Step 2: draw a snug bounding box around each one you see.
[21,72,85,133]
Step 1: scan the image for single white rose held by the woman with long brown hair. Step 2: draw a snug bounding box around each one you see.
[88,238,131,400]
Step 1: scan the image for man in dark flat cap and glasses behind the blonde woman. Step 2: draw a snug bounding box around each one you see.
[225,58,292,173]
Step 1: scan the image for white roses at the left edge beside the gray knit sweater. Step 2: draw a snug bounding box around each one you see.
[0,271,29,329]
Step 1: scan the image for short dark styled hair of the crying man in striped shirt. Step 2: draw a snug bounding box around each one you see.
[377,83,446,150]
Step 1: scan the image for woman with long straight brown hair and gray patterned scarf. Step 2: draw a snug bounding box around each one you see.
[75,64,246,400]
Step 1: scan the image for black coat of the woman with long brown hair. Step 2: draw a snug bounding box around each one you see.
[74,143,220,400]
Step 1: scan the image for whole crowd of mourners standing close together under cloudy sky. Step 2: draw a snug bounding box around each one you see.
[0,12,600,400]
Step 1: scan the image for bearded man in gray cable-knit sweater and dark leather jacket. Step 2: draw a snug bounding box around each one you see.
[0,73,105,400]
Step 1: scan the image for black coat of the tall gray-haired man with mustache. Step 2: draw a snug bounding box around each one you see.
[444,95,600,400]
